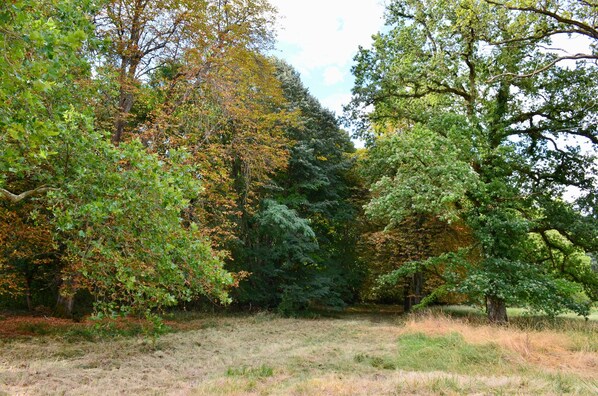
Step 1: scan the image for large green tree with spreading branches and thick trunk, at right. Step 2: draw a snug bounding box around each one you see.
[349,0,598,322]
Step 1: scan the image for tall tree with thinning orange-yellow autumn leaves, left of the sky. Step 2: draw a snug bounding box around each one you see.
[100,0,293,250]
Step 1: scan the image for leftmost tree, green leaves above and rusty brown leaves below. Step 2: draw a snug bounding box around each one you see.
[0,0,92,308]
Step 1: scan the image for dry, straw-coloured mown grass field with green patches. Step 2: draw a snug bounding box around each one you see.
[0,310,598,395]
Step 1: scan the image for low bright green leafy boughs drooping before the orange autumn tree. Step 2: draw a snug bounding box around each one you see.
[51,114,232,315]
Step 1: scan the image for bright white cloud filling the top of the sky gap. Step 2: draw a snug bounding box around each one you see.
[271,0,384,73]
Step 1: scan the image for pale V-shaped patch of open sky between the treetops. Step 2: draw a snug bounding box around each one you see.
[270,0,384,115]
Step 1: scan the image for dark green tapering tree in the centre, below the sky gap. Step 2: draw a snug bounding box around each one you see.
[232,61,360,314]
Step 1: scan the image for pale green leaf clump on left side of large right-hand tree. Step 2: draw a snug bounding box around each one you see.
[366,124,480,226]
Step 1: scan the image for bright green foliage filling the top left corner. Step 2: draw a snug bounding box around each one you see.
[0,0,90,188]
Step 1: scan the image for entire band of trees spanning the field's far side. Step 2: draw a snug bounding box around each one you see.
[0,0,598,321]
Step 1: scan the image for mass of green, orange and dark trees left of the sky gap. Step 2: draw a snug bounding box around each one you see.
[0,0,359,315]
